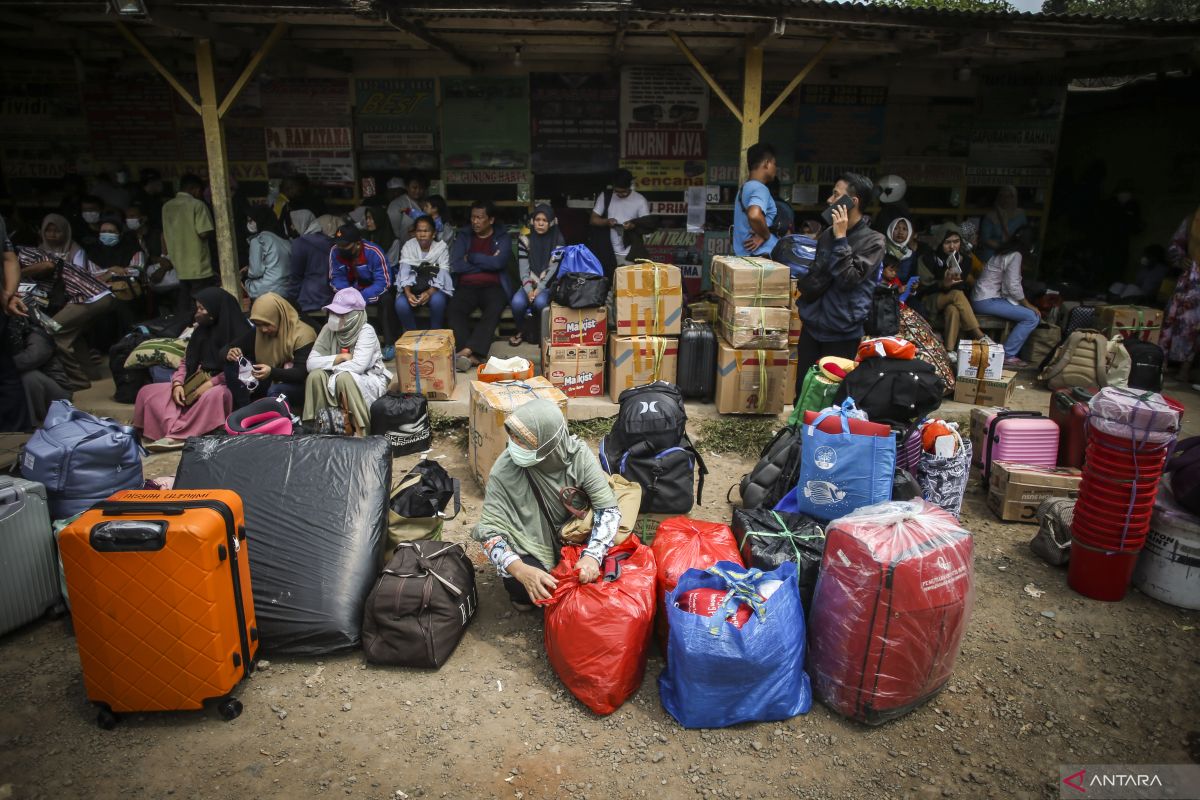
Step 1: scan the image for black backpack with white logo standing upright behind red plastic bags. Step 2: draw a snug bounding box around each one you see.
[600,380,708,513]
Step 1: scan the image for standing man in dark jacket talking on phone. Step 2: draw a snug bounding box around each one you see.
[796,173,887,399]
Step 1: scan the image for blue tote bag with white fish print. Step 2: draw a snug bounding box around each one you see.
[775,398,896,522]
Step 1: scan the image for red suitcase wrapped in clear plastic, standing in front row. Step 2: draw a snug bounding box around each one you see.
[809,500,974,724]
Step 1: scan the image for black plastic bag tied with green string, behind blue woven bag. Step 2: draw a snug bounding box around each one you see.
[730,509,824,614]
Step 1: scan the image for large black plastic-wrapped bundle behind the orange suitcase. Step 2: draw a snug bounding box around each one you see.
[175,435,391,656]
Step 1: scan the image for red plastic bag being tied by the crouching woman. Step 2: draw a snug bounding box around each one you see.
[544,536,658,715]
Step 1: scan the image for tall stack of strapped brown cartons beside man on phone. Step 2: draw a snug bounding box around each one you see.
[713,255,799,414]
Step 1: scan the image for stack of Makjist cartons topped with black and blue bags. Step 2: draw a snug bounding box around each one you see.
[541,245,610,397]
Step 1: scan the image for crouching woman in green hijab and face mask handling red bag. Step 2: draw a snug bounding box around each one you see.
[470,399,620,610]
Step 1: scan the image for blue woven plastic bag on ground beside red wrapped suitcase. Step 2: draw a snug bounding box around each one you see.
[659,561,812,728]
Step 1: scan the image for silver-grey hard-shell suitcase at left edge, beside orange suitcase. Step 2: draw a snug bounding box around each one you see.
[0,477,62,634]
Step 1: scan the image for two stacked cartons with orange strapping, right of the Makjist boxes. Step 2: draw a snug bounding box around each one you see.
[608,261,683,402]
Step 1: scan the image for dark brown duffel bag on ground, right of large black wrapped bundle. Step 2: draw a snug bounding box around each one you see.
[362,540,479,668]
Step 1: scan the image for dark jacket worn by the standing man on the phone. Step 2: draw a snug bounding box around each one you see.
[797,217,886,342]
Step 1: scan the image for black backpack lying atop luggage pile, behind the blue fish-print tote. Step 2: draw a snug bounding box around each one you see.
[834,356,946,427]
